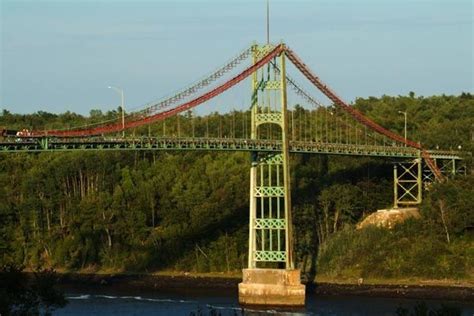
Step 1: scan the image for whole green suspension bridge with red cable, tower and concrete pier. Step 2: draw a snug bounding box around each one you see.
[0,43,463,305]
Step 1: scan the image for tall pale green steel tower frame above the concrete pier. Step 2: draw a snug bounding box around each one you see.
[248,45,294,269]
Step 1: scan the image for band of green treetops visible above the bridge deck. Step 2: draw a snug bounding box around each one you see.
[0,92,474,152]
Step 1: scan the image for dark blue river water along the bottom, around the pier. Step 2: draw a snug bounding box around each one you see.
[53,289,474,316]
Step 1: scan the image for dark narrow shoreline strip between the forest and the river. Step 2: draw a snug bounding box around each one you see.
[49,273,474,302]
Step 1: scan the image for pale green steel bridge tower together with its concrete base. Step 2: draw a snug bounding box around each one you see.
[239,45,305,306]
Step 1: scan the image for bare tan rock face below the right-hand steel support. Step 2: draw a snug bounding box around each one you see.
[356,207,421,229]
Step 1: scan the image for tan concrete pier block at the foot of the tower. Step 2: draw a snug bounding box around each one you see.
[239,269,305,306]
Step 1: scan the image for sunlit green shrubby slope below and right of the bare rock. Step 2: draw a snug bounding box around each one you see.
[317,175,474,282]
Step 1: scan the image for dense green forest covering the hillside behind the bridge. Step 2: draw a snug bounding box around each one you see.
[0,92,474,281]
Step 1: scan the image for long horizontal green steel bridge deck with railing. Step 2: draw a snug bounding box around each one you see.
[0,137,462,160]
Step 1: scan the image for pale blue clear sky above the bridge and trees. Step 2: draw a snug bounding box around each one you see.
[0,0,474,114]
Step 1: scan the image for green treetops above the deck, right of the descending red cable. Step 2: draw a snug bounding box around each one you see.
[354,93,474,152]
